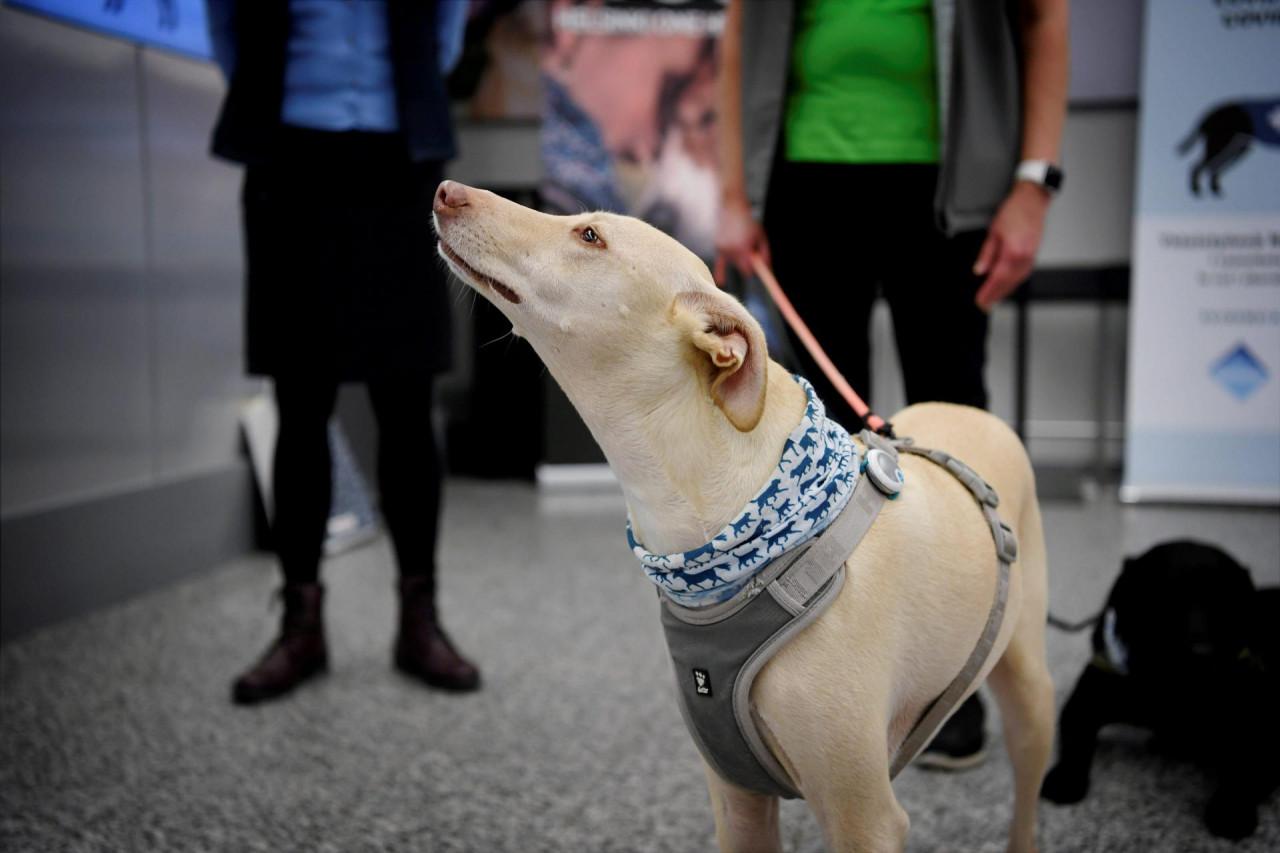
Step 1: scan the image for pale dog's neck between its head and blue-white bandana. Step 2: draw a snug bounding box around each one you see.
[566,361,806,553]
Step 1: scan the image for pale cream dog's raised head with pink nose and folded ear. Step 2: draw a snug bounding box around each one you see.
[434,181,768,432]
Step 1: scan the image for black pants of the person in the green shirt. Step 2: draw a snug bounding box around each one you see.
[764,161,987,429]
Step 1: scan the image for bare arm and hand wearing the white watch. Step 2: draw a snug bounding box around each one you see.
[973,0,1069,311]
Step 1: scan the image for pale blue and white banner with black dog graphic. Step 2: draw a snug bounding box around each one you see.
[1121,0,1280,503]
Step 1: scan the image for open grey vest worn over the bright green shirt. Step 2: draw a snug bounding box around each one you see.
[742,0,1023,234]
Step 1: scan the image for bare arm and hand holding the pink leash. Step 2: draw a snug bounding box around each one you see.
[714,0,772,284]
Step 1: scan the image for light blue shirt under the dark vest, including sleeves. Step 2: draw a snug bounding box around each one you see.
[207,0,467,132]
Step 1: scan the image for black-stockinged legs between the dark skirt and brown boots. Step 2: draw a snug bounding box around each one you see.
[273,374,442,596]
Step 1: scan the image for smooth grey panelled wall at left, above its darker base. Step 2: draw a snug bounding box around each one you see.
[0,8,256,637]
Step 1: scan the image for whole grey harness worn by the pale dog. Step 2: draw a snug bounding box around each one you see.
[659,430,1018,799]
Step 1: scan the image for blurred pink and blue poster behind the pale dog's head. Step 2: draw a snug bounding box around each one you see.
[541,0,724,259]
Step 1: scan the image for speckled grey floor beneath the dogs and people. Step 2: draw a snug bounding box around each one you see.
[0,483,1280,853]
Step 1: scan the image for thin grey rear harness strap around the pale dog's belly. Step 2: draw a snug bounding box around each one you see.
[890,443,1018,779]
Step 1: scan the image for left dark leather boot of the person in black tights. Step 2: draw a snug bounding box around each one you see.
[232,584,329,704]
